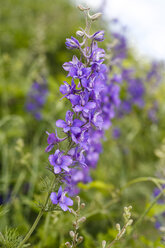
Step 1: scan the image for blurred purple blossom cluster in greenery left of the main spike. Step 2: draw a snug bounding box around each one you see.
[25,78,48,120]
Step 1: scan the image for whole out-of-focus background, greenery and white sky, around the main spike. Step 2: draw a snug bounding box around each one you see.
[0,0,165,248]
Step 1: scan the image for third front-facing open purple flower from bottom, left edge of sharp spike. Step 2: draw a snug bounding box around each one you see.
[56,111,84,134]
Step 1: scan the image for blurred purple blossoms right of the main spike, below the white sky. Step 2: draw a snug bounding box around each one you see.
[110,19,162,139]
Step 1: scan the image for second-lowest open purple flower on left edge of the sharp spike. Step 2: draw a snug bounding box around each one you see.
[49,149,73,174]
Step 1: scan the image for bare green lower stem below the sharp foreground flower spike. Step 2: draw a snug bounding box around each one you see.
[17,177,56,248]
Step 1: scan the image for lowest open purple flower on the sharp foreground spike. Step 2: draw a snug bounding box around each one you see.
[50,186,73,211]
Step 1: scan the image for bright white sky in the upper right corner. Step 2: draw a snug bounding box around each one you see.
[76,0,165,60]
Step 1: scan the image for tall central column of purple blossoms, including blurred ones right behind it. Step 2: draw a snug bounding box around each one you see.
[46,9,120,211]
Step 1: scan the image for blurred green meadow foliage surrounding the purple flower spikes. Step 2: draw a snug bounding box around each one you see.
[0,0,165,248]
